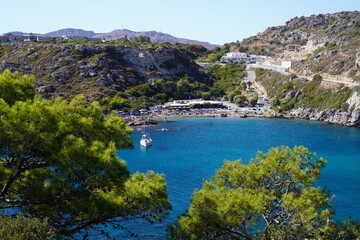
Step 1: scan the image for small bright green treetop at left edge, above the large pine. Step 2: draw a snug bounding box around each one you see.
[0,70,36,105]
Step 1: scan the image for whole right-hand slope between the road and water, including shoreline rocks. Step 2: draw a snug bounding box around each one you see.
[254,68,360,126]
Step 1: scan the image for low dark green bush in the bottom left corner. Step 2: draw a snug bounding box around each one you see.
[0,215,56,240]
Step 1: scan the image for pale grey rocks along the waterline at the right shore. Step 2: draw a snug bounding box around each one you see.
[289,108,360,126]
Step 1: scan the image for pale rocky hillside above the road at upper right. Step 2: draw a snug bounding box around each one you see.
[229,11,360,81]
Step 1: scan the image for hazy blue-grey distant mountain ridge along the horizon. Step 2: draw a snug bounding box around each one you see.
[2,28,220,49]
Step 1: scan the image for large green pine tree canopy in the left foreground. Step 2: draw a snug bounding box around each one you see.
[0,72,171,235]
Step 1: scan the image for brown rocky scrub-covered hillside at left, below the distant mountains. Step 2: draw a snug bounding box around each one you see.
[0,43,210,99]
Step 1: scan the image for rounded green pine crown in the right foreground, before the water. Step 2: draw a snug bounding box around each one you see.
[170,146,352,239]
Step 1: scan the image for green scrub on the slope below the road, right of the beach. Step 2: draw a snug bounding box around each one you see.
[255,68,355,111]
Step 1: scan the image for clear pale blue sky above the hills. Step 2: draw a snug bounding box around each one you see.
[0,0,360,44]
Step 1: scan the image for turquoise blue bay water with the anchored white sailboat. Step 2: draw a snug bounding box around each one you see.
[112,118,360,239]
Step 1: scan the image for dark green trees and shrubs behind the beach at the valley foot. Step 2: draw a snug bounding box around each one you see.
[102,63,247,111]
